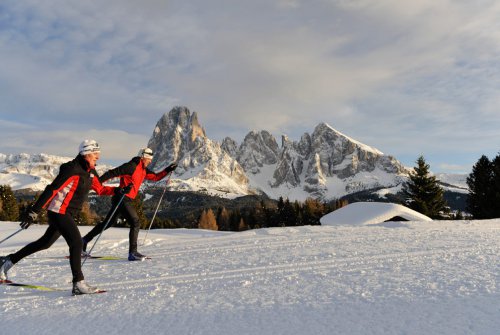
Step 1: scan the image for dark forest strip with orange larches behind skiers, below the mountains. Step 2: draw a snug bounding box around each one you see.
[0,185,347,231]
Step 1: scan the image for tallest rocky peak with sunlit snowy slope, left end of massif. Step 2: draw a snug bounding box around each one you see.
[148,107,248,193]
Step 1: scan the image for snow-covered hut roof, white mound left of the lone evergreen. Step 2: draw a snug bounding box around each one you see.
[320,202,432,226]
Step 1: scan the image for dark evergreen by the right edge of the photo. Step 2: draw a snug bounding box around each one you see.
[467,155,498,219]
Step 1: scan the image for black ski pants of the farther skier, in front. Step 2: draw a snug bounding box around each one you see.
[83,195,141,252]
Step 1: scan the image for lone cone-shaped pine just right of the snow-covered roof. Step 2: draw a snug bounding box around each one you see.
[403,156,447,219]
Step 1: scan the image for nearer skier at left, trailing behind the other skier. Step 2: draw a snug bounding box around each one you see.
[0,140,123,295]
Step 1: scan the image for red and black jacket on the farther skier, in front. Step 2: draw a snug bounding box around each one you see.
[100,157,167,199]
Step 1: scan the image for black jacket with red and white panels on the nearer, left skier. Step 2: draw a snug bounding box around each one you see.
[33,155,114,215]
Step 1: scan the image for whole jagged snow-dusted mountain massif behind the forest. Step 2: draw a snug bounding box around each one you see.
[148,107,407,200]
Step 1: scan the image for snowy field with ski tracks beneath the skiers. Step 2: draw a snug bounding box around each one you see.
[0,220,500,335]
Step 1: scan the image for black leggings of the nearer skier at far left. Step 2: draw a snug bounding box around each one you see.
[9,211,83,283]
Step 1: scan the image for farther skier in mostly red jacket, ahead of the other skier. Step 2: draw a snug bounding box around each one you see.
[82,148,177,261]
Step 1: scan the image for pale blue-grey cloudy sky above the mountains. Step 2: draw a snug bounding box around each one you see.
[0,0,500,173]
